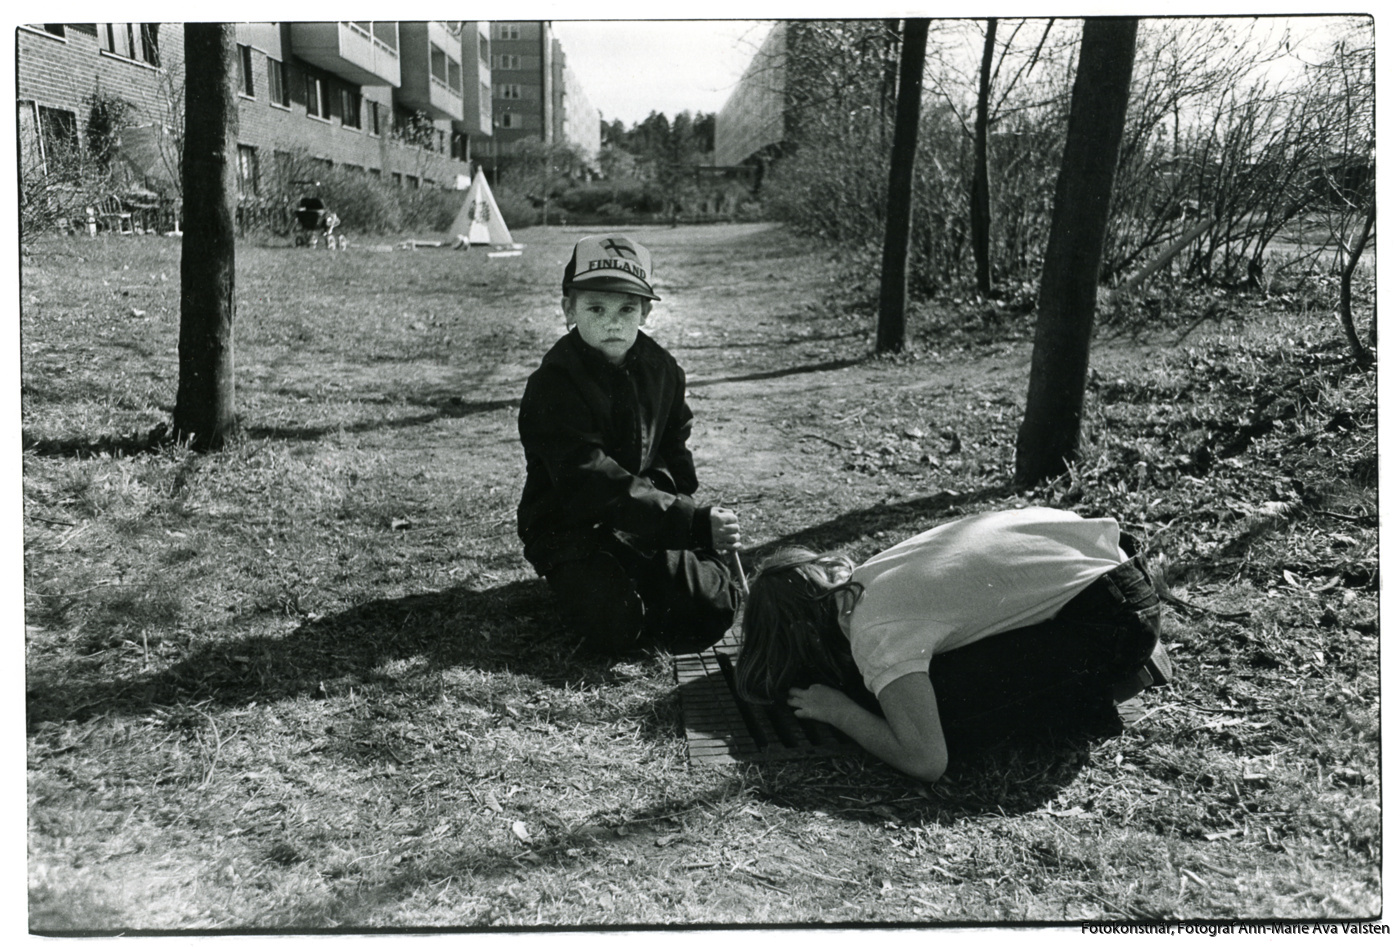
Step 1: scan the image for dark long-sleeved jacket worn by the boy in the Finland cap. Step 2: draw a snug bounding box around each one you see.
[517,329,711,573]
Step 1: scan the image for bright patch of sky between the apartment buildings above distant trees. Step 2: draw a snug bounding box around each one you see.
[553,20,771,127]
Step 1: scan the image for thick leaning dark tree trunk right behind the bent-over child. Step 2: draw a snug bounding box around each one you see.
[1015,18,1137,486]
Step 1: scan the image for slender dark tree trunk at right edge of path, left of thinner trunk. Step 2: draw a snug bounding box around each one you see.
[875,18,928,352]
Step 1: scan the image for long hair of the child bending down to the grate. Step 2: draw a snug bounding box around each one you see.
[735,546,864,703]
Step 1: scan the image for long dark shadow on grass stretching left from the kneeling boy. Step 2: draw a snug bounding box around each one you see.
[28,580,627,727]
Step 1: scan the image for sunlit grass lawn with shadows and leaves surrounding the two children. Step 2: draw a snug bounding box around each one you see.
[21,226,1382,932]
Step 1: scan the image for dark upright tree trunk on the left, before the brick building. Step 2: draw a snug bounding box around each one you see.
[174,22,238,450]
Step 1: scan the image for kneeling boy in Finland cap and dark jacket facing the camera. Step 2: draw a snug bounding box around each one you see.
[517,234,739,654]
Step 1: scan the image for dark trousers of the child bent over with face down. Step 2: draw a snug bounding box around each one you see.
[928,558,1162,754]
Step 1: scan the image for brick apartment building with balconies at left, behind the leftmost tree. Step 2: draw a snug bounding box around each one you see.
[17,21,493,214]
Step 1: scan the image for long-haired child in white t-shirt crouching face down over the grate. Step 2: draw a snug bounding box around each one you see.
[736,507,1170,782]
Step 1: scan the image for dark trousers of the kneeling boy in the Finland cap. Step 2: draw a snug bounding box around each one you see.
[545,528,739,654]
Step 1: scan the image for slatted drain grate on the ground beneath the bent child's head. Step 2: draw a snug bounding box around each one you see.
[675,632,860,762]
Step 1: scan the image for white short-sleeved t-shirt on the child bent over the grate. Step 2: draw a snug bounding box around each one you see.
[841,507,1127,695]
